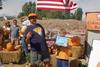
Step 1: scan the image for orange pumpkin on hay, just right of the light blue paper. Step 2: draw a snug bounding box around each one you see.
[68,36,80,46]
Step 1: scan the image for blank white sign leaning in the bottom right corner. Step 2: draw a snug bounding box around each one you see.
[88,40,100,67]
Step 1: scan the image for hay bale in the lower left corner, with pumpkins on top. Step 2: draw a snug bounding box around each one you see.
[0,49,22,63]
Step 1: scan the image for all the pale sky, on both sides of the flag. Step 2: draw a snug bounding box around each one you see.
[0,0,100,16]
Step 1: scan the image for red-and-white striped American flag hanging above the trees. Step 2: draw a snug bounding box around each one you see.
[36,0,77,10]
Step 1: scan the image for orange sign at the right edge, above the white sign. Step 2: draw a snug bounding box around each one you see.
[86,12,100,30]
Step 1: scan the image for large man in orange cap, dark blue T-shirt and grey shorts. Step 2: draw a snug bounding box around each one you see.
[25,13,50,67]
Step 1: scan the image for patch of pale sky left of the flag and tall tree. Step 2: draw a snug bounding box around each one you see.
[0,0,35,16]
